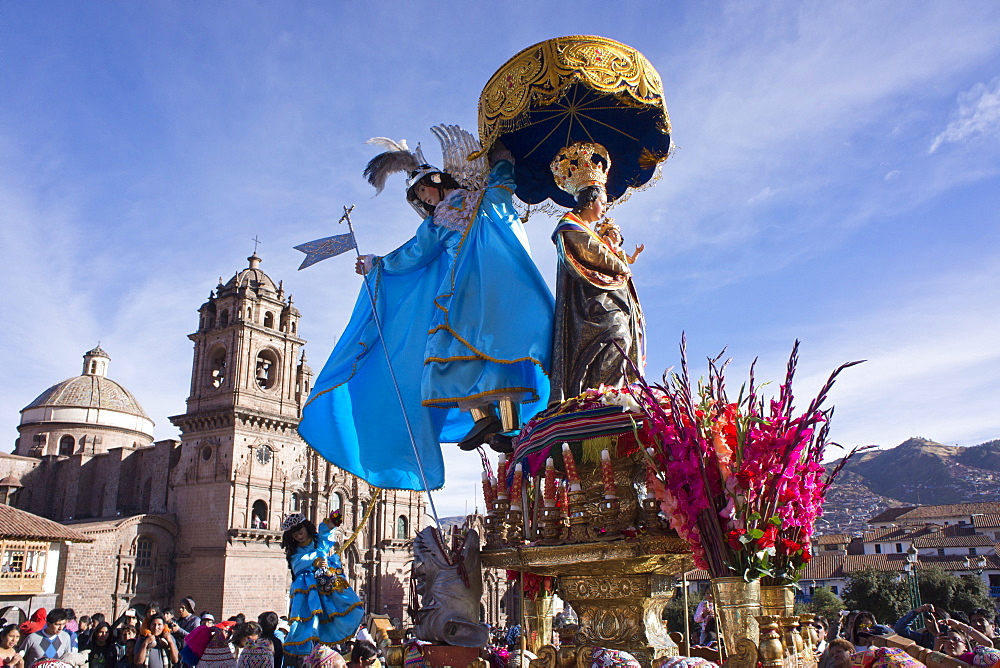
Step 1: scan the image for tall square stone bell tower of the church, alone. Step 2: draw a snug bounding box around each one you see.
[170,252,316,615]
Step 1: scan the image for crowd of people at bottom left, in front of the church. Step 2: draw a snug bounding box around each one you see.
[0,598,381,668]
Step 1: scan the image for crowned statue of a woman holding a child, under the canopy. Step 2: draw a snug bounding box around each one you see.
[550,142,646,403]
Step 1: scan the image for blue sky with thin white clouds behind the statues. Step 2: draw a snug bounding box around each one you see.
[0,0,1000,514]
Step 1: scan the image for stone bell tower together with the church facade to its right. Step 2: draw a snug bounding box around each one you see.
[167,253,426,618]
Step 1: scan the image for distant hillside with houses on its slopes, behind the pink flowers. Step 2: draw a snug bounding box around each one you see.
[817,438,1000,534]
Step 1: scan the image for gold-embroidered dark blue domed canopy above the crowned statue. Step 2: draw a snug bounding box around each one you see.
[479,36,670,207]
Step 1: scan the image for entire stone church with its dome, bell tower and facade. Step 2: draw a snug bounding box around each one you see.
[0,253,428,619]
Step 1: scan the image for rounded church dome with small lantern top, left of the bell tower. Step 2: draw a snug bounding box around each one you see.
[21,345,153,438]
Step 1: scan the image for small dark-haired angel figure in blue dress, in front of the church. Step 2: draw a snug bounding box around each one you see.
[281,510,365,656]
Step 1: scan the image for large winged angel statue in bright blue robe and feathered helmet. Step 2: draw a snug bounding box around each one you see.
[299,125,554,490]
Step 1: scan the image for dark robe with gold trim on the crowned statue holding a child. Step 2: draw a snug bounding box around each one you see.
[549,213,646,405]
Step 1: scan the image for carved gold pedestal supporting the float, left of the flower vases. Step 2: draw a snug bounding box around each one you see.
[559,573,677,666]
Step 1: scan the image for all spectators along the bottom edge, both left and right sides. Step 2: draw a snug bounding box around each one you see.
[0,596,1000,668]
